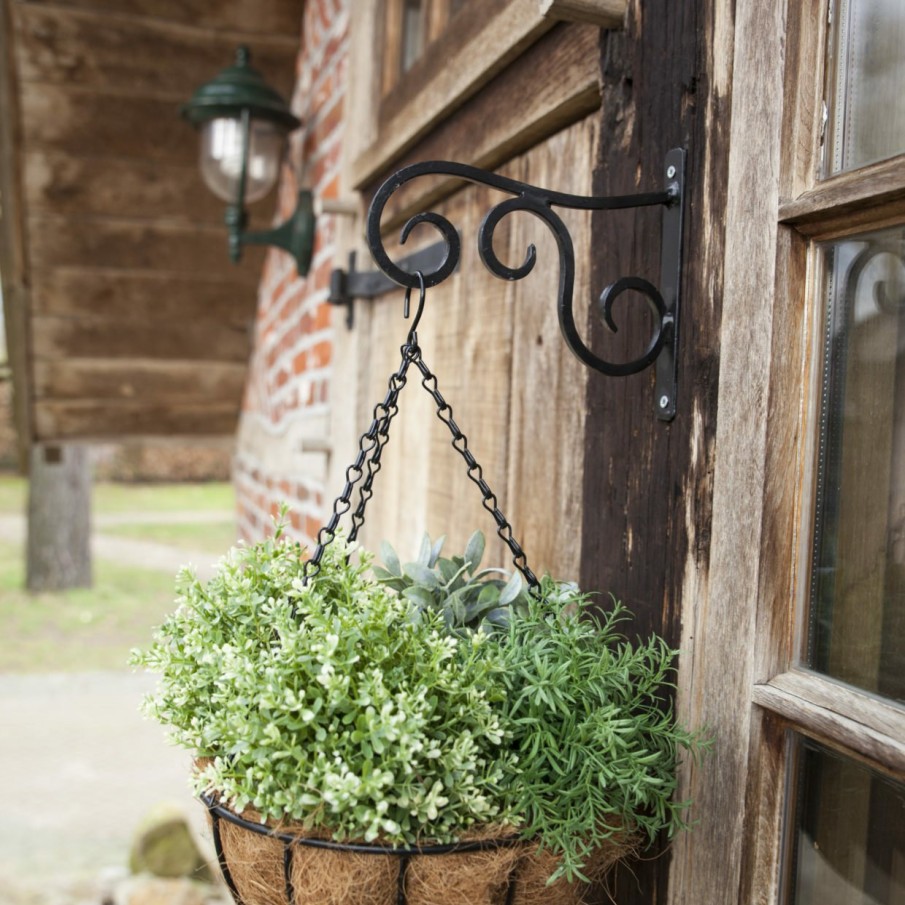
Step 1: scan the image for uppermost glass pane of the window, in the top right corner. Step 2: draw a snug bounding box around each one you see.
[826,0,905,174]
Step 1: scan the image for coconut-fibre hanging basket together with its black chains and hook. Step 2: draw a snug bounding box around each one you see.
[194,274,634,905]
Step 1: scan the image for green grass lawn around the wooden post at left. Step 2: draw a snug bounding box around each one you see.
[0,475,236,673]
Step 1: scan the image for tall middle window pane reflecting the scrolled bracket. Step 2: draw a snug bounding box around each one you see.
[808,227,905,701]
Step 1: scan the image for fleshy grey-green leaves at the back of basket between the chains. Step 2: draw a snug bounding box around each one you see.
[373,531,529,632]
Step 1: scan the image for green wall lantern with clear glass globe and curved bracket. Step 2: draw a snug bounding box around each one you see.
[181,47,315,276]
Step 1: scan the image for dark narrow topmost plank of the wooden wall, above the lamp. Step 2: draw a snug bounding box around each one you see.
[17,0,302,37]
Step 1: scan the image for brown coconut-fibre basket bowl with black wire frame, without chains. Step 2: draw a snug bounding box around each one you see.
[202,796,632,905]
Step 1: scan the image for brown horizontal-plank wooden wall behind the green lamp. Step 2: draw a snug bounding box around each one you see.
[4,0,301,441]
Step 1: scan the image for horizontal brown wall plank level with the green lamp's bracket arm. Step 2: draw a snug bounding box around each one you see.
[28,215,265,276]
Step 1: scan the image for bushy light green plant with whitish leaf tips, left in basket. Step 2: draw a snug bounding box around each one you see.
[133,512,513,843]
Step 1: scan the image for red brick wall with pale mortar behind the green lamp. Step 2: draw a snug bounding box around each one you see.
[233,0,351,541]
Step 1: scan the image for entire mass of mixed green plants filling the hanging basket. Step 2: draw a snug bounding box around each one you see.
[133,508,704,879]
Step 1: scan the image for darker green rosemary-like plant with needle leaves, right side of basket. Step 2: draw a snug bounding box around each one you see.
[500,577,702,879]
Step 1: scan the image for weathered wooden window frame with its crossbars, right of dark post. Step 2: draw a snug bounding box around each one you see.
[666,0,905,905]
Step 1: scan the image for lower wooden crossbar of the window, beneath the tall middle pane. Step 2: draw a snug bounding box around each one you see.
[752,670,905,773]
